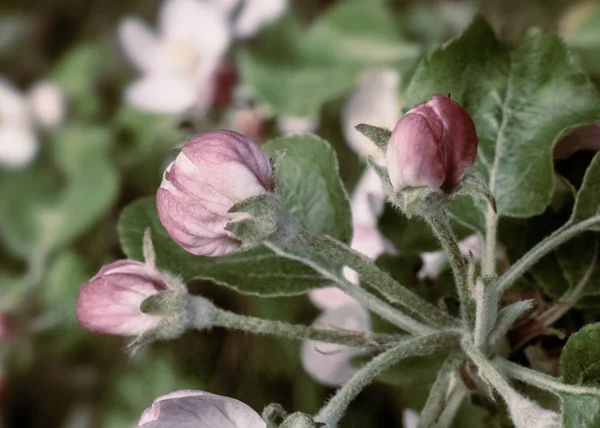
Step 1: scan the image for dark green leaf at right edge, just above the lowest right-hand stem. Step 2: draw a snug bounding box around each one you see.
[560,323,600,386]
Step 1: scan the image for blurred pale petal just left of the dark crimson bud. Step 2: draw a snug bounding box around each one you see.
[342,68,400,160]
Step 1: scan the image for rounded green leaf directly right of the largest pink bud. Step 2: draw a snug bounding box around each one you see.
[263,135,352,243]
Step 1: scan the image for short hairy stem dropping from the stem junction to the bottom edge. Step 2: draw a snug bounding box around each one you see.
[417,355,461,428]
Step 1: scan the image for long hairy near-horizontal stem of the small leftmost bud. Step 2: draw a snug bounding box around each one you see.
[211,307,402,348]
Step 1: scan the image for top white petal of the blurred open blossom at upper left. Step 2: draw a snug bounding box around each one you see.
[159,0,231,59]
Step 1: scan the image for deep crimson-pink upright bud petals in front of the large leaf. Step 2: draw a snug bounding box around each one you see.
[386,94,478,191]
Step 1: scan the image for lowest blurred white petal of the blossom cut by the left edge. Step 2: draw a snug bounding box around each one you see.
[0,127,39,168]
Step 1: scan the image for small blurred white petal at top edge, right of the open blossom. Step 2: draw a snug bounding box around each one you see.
[235,0,288,39]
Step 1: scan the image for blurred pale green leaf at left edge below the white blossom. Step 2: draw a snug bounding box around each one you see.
[0,126,118,259]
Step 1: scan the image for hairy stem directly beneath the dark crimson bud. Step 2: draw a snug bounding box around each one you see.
[424,207,475,327]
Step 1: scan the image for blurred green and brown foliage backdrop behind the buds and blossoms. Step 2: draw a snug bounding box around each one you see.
[0,0,600,428]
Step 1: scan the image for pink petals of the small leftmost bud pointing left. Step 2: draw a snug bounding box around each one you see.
[75,260,167,336]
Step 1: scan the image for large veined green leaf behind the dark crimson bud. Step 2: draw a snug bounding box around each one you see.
[405,19,600,218]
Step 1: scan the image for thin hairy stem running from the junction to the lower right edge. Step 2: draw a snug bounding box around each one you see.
[493,358,600,397]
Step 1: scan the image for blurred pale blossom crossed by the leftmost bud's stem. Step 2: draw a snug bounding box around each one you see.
[300,302,371,386]
